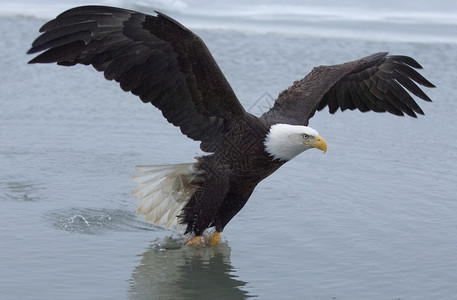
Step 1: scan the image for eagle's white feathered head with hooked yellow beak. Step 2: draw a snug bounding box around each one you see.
[264,124,327,160]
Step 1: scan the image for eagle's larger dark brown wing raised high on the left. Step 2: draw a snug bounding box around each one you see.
[28,6,245,142]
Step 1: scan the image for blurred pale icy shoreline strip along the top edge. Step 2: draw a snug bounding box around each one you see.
[0,0,457,44]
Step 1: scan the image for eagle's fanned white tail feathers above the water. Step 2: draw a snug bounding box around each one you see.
[132,163,203,229]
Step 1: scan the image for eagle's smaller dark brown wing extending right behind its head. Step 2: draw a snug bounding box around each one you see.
[262,52,434,125]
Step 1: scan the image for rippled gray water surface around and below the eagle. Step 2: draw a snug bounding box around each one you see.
[0,17,457,299]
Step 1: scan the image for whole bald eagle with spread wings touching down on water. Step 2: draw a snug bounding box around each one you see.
[28,6,434,245]
